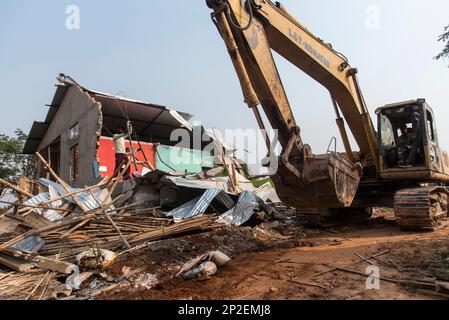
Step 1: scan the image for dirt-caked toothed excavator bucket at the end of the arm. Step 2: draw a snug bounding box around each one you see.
[273,153,362,208]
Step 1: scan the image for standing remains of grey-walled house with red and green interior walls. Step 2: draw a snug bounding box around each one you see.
[23,75,219,186]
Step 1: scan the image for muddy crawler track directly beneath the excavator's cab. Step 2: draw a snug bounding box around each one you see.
[394,186,449,231]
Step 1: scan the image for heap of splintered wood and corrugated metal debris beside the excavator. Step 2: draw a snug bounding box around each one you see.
[0,154,288,299]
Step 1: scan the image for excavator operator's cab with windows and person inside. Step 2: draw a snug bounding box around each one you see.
[376,99,447,180]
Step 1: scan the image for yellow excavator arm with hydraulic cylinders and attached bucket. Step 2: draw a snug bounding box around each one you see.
[206,0,379,208]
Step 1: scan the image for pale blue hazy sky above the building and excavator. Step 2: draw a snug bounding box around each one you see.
[0,0,449,162]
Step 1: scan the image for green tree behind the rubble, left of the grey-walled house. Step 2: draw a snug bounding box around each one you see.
[0,129,34,183]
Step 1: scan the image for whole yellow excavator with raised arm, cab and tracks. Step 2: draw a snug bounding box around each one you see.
[206,0,449,230]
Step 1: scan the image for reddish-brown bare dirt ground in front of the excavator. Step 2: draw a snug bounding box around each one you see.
[93,215,449,300]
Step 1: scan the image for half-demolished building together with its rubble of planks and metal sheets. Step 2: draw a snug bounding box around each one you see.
[0,76,294,300]
